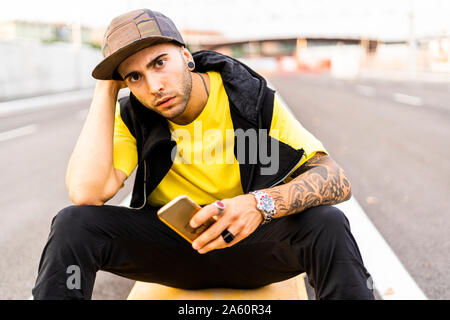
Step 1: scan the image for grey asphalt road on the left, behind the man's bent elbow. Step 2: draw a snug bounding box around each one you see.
[0,92,134,299]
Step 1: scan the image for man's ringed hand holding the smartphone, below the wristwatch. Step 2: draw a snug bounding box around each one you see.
[190,194,263,253]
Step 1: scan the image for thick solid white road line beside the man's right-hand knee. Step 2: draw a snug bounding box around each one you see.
[335,197,427,300]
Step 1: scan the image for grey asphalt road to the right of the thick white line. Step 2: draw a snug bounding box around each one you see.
[271,75,450,299]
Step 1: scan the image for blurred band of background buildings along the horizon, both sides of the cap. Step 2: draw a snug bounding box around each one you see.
[0,20,450,87]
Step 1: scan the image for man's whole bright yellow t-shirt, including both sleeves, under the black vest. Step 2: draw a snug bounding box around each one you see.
[114,71,327,206]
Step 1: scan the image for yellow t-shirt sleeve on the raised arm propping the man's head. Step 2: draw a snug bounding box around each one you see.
[113,102,138,182]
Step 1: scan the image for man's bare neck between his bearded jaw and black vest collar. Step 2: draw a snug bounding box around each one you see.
[170,72,209,125]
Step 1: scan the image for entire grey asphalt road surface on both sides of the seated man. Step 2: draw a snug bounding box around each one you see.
[0,75,450,299]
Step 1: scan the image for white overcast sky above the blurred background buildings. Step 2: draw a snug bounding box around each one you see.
[0,0,450,39]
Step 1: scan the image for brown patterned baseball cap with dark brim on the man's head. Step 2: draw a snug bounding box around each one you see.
[92,9,185,80]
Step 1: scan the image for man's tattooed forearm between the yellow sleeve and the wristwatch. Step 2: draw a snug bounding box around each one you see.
[265,153,351,217]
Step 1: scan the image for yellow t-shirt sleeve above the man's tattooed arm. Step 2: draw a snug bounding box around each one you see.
[269,94,328,182]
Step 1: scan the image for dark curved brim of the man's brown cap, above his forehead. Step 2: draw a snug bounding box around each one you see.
[92,36,184,80]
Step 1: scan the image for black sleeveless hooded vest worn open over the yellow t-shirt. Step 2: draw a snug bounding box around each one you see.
[119,50,304,208]
